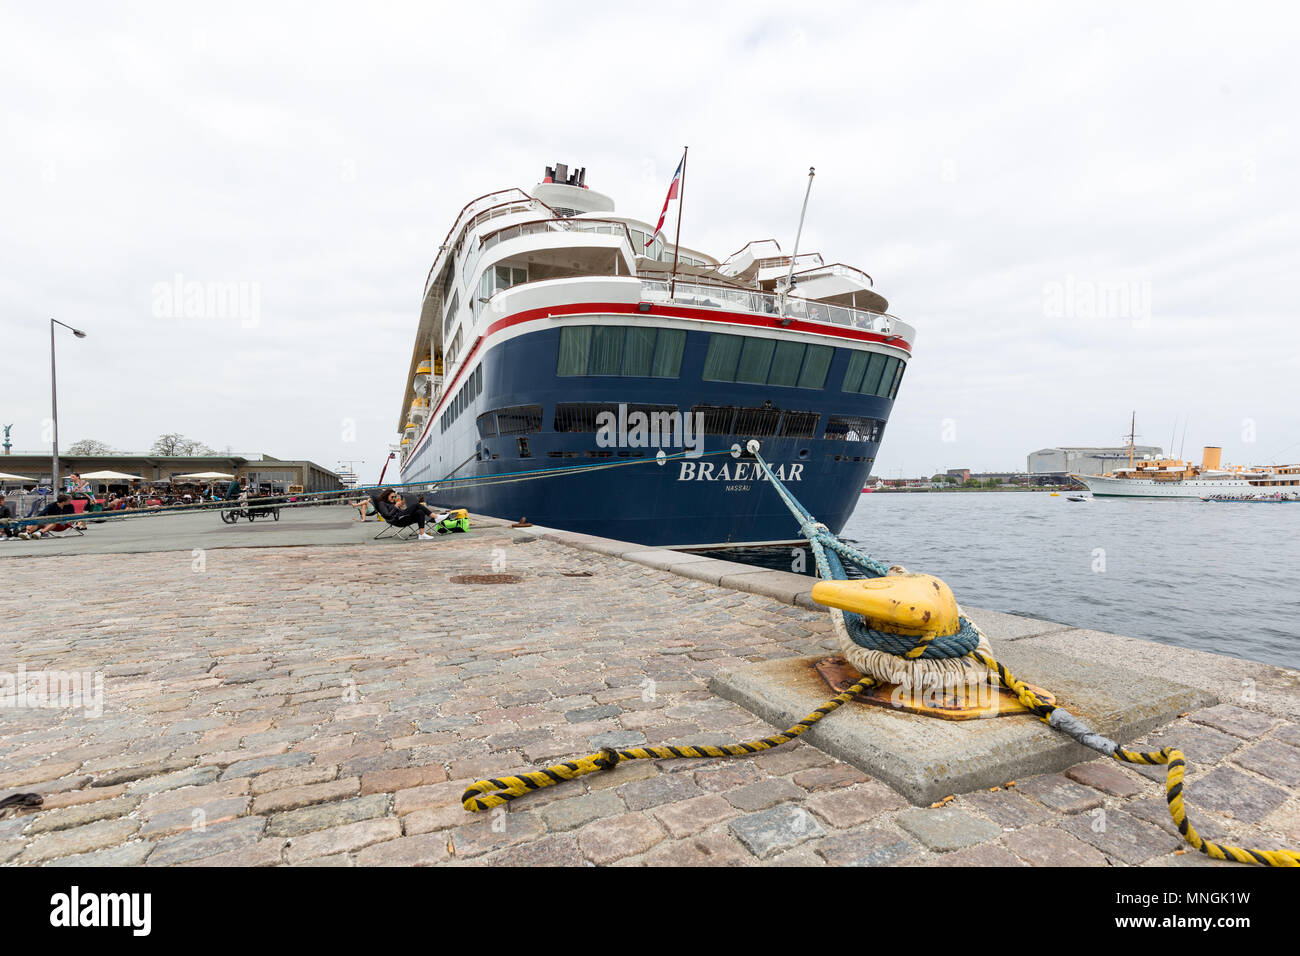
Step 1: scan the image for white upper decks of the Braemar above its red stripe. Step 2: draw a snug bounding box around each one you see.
[398,165,915,431]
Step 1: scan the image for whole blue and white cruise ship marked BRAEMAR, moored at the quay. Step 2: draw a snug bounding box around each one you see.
[398,164,915,548]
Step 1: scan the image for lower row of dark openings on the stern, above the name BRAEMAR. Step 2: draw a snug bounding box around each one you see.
[477,402,885,442]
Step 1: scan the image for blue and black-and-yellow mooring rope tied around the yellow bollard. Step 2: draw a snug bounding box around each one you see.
[460,444,1300,866]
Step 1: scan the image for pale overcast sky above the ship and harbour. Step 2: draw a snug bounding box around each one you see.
[0,3,1300,480]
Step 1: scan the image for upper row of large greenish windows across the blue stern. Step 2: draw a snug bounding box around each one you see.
[555,325,907,399]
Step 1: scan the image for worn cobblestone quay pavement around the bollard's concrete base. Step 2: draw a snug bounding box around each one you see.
[0,529,1300,866]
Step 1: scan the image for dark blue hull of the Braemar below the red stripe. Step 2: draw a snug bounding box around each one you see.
[402,328,893,546]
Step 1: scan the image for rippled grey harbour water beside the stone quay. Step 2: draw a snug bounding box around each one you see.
[716,492,1300,667]
